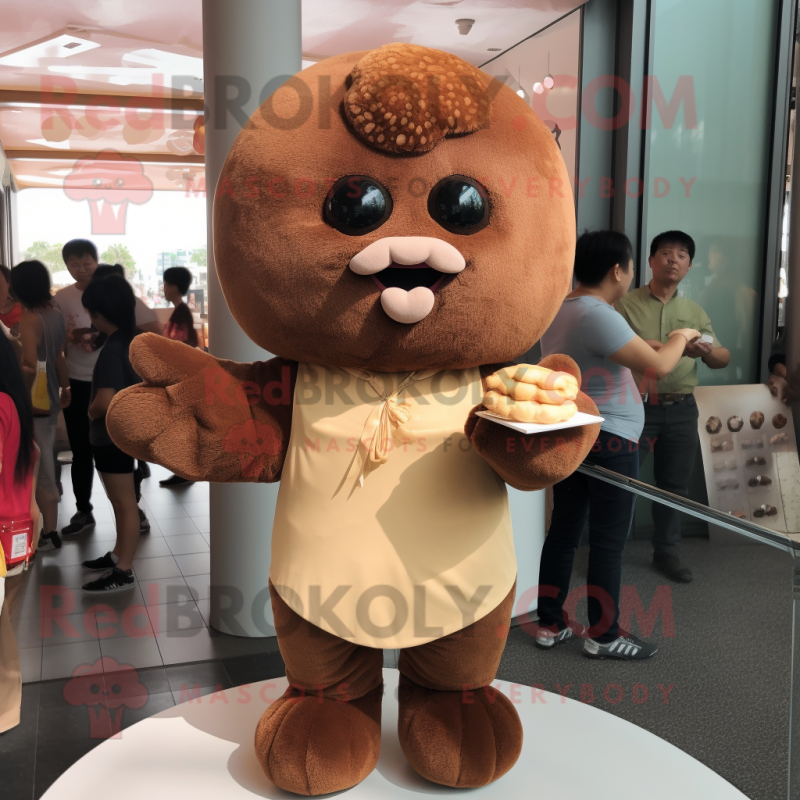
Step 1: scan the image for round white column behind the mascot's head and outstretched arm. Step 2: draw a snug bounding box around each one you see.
[203,0,302,637]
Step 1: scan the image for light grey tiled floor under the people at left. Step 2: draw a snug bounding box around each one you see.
[12,465,274,683]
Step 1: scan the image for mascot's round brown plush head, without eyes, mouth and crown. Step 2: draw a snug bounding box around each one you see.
[214,53,575,372]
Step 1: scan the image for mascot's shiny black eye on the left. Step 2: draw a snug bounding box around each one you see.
[324,175,392,236]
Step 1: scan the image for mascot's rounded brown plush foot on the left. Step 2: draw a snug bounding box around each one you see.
[255,684,383,795]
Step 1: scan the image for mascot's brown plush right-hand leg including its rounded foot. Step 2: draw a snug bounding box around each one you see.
[398,589,522,788]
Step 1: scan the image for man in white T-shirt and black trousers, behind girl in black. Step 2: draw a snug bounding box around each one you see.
[55,239,162,536]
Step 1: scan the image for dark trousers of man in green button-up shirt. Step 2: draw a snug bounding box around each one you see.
[639,395,699,555]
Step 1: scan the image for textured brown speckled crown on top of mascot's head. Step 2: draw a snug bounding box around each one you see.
[344,43,489,153]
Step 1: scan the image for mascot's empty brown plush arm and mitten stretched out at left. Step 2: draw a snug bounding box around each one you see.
[106,333,297,483]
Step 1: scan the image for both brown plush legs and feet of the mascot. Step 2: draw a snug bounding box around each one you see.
[266,583,522,794]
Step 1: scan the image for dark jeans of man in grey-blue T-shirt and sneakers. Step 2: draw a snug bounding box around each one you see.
[539,431,639,642]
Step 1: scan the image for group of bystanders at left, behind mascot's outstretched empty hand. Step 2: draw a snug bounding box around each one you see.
[0,239,199,593]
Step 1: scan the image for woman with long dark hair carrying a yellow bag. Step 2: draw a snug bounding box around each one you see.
[11,261,71,550]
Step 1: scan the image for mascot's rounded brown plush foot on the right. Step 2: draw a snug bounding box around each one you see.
[398,675,522,789]
